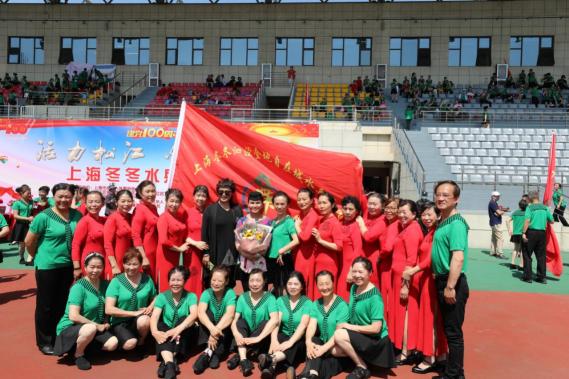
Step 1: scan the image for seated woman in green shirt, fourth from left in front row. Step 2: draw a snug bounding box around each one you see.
[193,266,237,375]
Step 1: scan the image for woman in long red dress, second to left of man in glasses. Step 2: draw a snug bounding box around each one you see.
[387,200,423,365]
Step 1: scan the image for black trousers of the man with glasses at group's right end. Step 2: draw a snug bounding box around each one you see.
[435,274,470,379]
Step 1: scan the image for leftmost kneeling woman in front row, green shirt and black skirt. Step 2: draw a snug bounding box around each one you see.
[54,253,118,370]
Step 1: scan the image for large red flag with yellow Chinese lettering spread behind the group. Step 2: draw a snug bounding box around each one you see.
[172,105,363,217]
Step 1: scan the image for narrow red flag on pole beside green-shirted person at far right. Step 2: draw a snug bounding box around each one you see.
[543,133,563,276]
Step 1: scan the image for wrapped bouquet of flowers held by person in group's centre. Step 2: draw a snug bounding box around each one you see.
[235,222,273,273]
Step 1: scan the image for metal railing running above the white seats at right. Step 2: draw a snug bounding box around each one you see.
[418,109,569,128]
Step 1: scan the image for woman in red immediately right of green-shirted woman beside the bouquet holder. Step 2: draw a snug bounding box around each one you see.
[294,188,320,300]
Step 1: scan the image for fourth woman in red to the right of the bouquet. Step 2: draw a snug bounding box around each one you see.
[356,192,387,288]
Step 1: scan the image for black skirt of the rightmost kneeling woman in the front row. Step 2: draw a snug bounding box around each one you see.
[347,330,395,368]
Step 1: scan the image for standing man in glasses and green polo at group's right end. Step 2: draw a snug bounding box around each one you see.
[431,180,469,379]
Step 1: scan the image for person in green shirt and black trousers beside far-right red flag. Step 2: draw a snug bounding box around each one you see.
[522,191,553,284]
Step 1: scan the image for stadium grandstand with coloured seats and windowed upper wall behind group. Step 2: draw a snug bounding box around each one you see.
[0,0,569,243]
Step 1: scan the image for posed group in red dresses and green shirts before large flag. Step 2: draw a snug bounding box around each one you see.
[0,179,469,378]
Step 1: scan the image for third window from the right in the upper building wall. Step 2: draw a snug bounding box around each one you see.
[389,38,431,67]
